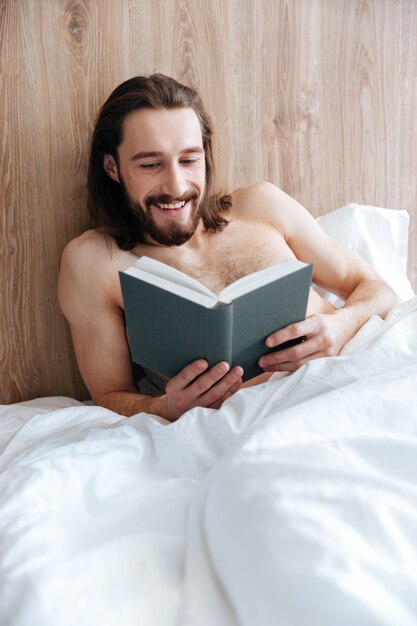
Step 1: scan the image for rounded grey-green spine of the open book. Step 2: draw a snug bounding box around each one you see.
[205,304,233,367]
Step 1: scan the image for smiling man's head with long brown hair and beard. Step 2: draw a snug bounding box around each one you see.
[89,74,226,250]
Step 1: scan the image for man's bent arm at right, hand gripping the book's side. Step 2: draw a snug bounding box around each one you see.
[244,183,399,372]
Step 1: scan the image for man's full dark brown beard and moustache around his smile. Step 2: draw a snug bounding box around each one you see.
[119,172,203,246]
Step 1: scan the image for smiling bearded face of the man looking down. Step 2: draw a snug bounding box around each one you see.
[105,108,206,246]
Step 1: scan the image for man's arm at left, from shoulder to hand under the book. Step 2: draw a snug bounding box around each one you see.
[58,234,242,421]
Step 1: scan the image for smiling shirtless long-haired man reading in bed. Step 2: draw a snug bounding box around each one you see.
[59,74,397,421]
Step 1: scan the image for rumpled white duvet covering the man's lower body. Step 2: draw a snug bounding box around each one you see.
[0,298,417,626]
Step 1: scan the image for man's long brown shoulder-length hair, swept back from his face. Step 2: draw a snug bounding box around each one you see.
[88,74,231,250]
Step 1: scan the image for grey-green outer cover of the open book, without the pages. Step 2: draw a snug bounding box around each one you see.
[119,263,312,380]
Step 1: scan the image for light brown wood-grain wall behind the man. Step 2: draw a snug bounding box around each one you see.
[0,0,417,403]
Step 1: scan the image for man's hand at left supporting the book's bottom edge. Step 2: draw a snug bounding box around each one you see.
[161,359,243,422]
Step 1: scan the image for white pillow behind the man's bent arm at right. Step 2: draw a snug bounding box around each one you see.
[315,204,415,306]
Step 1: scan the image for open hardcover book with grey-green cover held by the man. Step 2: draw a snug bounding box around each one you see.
[119,257,312,380]
